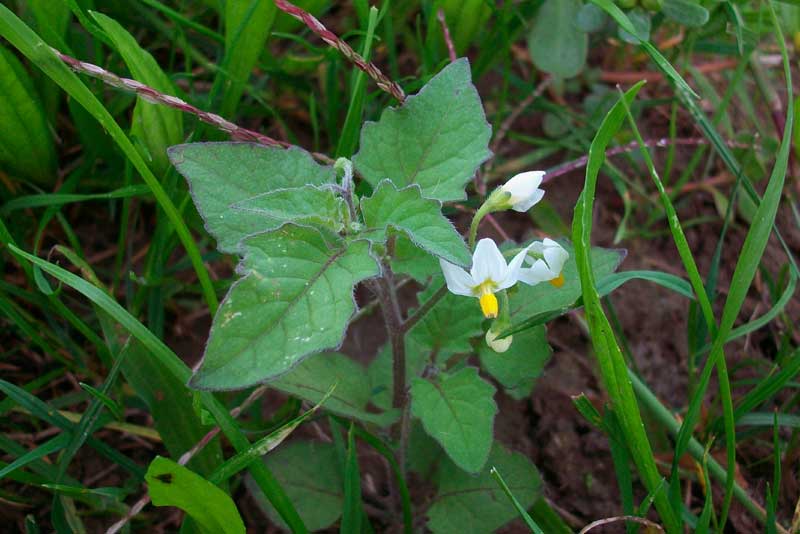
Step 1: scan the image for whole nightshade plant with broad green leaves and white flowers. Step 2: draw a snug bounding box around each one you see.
[169,59,622,532]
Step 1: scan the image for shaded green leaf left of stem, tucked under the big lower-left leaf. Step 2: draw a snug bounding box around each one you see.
[270,352,397,426]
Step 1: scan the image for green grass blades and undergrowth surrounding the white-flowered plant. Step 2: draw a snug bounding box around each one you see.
[0,0,800,532]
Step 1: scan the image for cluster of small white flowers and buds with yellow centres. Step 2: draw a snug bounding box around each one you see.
[439,171,569,352]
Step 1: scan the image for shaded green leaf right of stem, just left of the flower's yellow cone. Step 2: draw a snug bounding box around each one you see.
[407,282,483,357]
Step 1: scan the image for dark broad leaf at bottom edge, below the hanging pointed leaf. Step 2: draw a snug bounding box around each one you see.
[428,443,542,534]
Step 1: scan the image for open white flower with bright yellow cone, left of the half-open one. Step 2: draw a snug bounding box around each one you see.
[439,239,528,319]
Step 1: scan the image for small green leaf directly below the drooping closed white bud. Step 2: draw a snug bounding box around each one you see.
[478,325,553,399]
